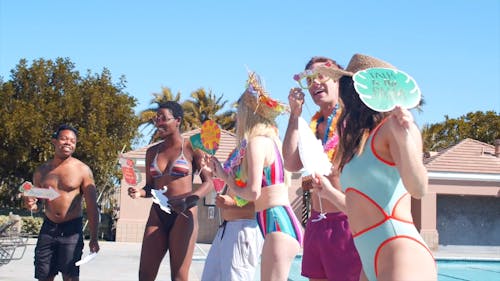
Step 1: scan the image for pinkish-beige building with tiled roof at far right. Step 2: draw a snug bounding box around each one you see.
[412,139,500,249]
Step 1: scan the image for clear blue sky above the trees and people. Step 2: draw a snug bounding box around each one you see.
[0,0,500,143]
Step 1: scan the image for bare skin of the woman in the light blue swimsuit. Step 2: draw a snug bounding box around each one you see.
[314,107,437,280]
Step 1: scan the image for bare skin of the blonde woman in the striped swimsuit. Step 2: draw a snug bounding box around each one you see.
[210,97,300,280]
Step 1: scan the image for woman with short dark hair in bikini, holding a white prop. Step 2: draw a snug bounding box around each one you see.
[129,101,212,281]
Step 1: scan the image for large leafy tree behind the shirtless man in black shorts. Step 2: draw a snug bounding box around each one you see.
[0,58,139,207]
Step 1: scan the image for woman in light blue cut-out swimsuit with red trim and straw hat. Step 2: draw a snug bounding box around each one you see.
[316,54,437,281]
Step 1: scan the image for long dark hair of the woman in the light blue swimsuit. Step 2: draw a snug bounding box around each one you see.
[335,76,388,171]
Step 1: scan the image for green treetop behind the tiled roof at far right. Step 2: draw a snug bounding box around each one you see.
[422,111,500,151]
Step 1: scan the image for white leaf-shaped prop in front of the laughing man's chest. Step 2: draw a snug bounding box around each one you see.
[298,117,332,176]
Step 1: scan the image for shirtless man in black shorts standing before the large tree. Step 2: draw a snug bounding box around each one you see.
[24,125,99,281]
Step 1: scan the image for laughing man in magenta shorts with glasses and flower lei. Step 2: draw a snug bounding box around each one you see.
[283,58,363,281]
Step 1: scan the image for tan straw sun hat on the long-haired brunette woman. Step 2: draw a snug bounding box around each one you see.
[316,54,396,81]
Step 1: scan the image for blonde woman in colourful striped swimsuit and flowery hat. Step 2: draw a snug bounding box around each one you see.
[211,73,302,280]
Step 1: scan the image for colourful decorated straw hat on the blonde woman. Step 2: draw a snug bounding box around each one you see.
[241,72,288,120]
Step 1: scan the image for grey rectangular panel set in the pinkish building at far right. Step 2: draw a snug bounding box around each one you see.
[437,195,500,246]
